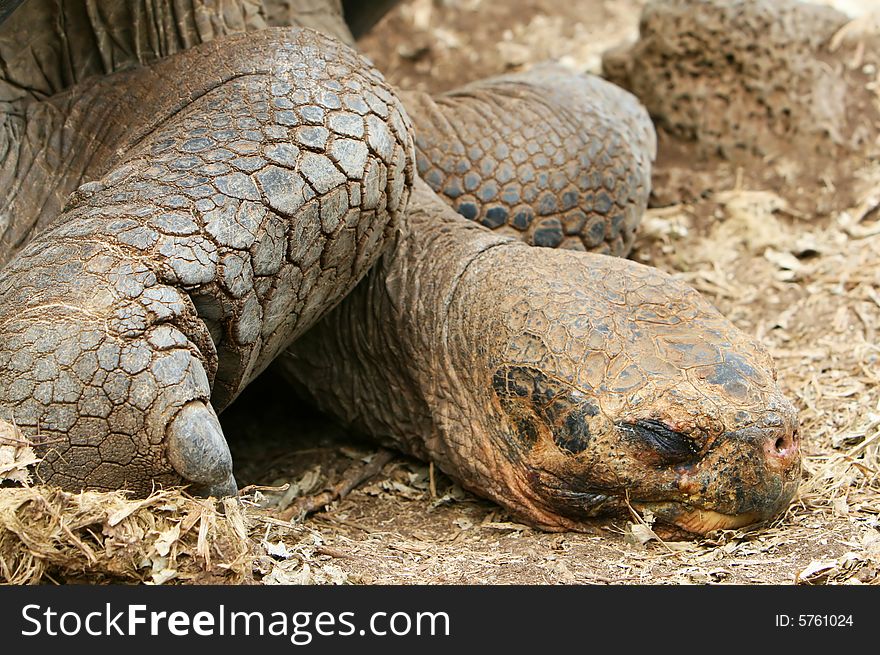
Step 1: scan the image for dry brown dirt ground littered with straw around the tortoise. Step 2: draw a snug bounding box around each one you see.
[0,0,880,584]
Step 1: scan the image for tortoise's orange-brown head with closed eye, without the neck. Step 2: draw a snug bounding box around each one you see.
[450,243,800,533]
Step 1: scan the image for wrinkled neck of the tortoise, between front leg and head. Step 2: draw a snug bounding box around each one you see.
[278,180,512,462]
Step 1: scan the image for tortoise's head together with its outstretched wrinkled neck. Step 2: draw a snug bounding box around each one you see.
[279,181,800,533]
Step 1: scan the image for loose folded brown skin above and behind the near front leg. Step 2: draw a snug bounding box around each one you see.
[0,0,354,266]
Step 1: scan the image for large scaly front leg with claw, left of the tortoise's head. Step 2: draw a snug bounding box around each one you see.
[0,29,414,494]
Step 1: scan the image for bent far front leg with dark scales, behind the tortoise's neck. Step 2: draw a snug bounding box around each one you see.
[402,65,656,256]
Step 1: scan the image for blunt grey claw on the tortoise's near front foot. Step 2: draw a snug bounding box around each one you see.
[166,401,238,497]
